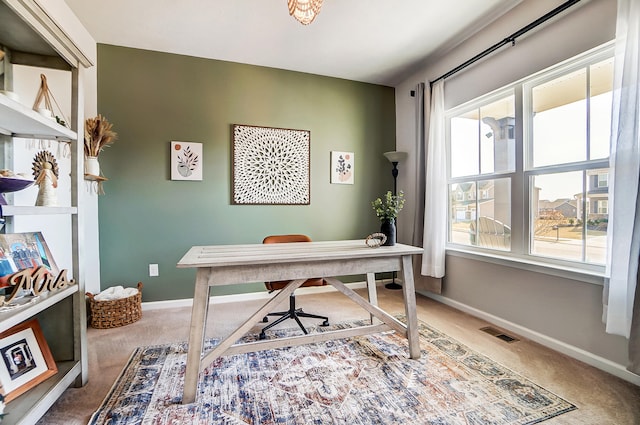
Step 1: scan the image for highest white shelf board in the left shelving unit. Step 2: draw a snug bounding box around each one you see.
[0,94,77,140]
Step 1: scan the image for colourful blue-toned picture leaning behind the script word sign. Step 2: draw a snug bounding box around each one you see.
[0,232,59,288]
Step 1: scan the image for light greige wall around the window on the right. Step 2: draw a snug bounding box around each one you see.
[396,0,640,383]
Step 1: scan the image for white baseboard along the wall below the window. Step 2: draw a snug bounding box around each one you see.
[418,291,640,386]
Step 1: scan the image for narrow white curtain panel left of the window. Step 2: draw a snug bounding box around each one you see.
[421,80,448,278]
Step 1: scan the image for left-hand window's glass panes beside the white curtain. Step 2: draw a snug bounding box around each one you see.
[448,91,516,251]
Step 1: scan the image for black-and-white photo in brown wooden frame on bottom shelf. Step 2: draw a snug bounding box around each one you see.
[0,319,58,403]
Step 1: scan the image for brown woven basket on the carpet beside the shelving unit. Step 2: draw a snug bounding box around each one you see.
[87,282,142,329]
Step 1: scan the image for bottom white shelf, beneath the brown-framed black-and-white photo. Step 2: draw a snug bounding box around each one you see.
[2,361,81,425]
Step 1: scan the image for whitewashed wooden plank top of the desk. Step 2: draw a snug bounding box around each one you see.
[177,239,423,268]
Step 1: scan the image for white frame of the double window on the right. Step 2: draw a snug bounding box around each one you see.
[445,42,614,276]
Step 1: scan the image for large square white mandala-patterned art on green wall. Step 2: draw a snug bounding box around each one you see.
[231,124,311,205]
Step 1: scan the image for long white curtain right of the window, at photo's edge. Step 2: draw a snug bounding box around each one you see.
[605,0,640,372]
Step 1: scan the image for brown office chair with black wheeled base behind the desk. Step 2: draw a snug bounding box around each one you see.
[260,235,329,339]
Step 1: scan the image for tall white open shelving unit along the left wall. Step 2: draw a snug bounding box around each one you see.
[0,0,93,425]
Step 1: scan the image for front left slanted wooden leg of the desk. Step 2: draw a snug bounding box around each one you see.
[182,268,210,404]
